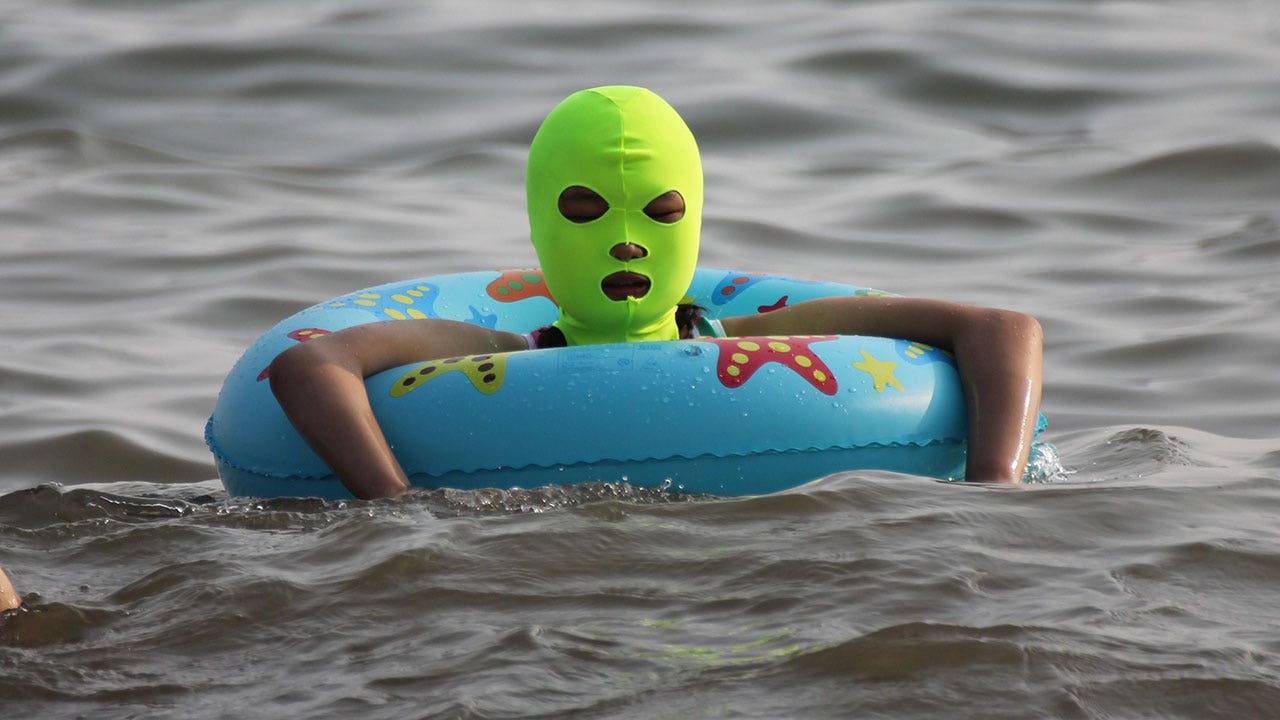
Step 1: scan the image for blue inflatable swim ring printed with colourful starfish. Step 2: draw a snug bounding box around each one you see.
[205,269,1034,498]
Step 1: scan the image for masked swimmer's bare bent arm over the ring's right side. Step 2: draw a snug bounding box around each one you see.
[723,297,1043,483]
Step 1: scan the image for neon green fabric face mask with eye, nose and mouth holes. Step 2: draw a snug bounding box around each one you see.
[526,86,703,345]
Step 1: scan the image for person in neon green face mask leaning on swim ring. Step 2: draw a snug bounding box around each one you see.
[270,86,1042,498]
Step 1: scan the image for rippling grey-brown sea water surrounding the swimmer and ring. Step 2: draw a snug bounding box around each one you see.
[0,0,1280,720]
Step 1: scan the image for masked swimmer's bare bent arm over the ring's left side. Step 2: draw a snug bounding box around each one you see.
[270,320,526,498]
